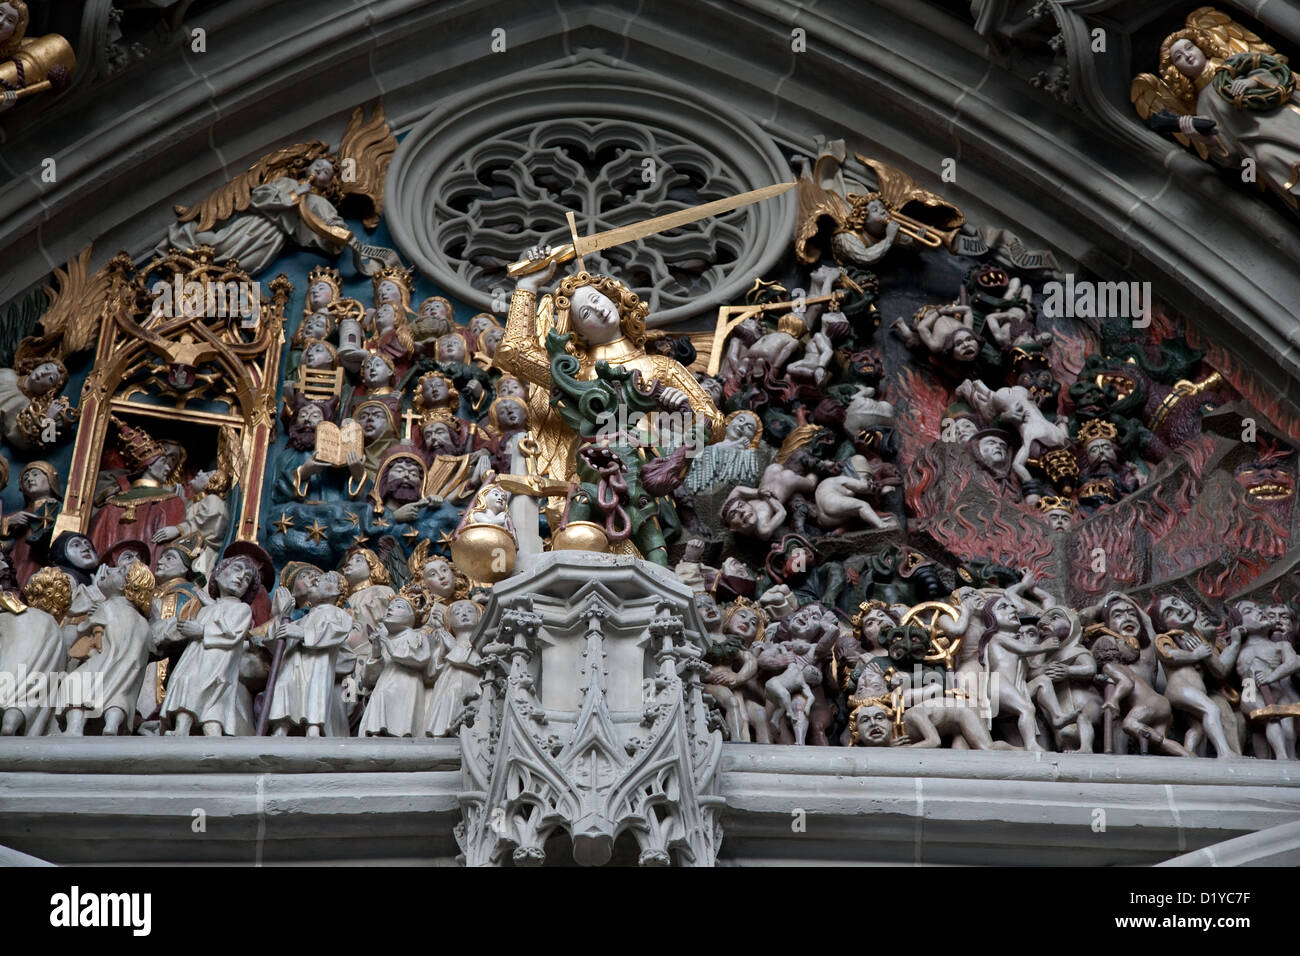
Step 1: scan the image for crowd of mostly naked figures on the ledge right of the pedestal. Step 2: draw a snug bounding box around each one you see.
[697,574,1300,760]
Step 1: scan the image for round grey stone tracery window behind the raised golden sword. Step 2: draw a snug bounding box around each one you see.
[385,61,794,325]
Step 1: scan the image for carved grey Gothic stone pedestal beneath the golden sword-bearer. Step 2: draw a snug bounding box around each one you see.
[456,551,723,866]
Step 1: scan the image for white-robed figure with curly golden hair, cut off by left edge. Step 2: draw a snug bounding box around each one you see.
[0,567,73,737]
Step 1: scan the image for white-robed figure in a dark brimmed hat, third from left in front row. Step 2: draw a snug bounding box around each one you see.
[163,555,259,736]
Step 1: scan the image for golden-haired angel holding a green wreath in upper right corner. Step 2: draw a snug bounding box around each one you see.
[1128,7,1300,213]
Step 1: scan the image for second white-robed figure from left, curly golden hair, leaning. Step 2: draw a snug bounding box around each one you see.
[57,561,153,736]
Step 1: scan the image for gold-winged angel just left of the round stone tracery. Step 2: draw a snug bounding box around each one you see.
[156,105,397,274]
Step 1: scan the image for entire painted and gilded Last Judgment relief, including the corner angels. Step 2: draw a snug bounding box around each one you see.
[0,4,1300,770]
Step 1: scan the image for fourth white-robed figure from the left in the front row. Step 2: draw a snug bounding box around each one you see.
[268,571,359,737]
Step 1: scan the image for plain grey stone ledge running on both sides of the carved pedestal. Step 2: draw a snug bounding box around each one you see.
[0,737,1300,865]
